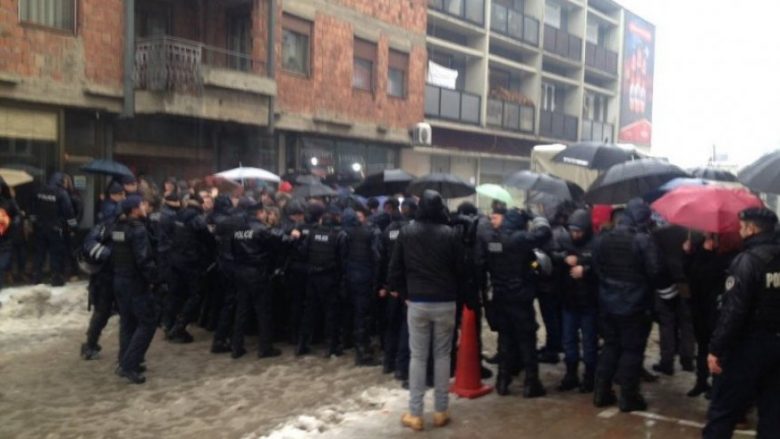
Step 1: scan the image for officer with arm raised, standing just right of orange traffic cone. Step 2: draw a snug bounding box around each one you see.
[475,209,552,398]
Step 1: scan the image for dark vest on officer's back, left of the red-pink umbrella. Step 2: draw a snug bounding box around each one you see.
[599,229,645,283]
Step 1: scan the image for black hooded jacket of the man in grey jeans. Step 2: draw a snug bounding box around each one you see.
[388,191,467,302]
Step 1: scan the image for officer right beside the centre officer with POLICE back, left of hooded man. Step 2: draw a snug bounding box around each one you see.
[341,209,380,366]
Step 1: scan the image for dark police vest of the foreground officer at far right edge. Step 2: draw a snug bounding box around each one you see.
[748,245,780,332]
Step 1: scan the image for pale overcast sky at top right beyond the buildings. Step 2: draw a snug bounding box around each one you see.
[618,0,780,166]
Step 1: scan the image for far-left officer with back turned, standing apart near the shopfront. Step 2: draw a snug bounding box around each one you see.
[33,172,78,286]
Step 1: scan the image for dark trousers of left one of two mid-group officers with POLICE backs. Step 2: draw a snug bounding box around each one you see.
[231,266,273,353]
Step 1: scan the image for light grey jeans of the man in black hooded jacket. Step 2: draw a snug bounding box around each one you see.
[407,302,456,416]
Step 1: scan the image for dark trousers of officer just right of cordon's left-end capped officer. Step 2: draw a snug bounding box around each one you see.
[164,265,204,329]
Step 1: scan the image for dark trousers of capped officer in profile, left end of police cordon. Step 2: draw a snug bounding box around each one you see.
[113,275,157,371]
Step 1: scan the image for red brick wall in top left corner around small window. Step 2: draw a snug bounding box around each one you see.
[0,0,123,86]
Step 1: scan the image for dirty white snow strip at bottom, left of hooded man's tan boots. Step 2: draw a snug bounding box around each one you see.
[251,387,408,439]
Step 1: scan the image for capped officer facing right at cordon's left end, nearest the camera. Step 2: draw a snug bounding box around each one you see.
[111,195,159,384]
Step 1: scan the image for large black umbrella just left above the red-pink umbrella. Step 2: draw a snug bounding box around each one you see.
[585,159,689,204]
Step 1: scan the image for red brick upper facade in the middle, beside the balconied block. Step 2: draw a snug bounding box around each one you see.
[276,0,427,128]
